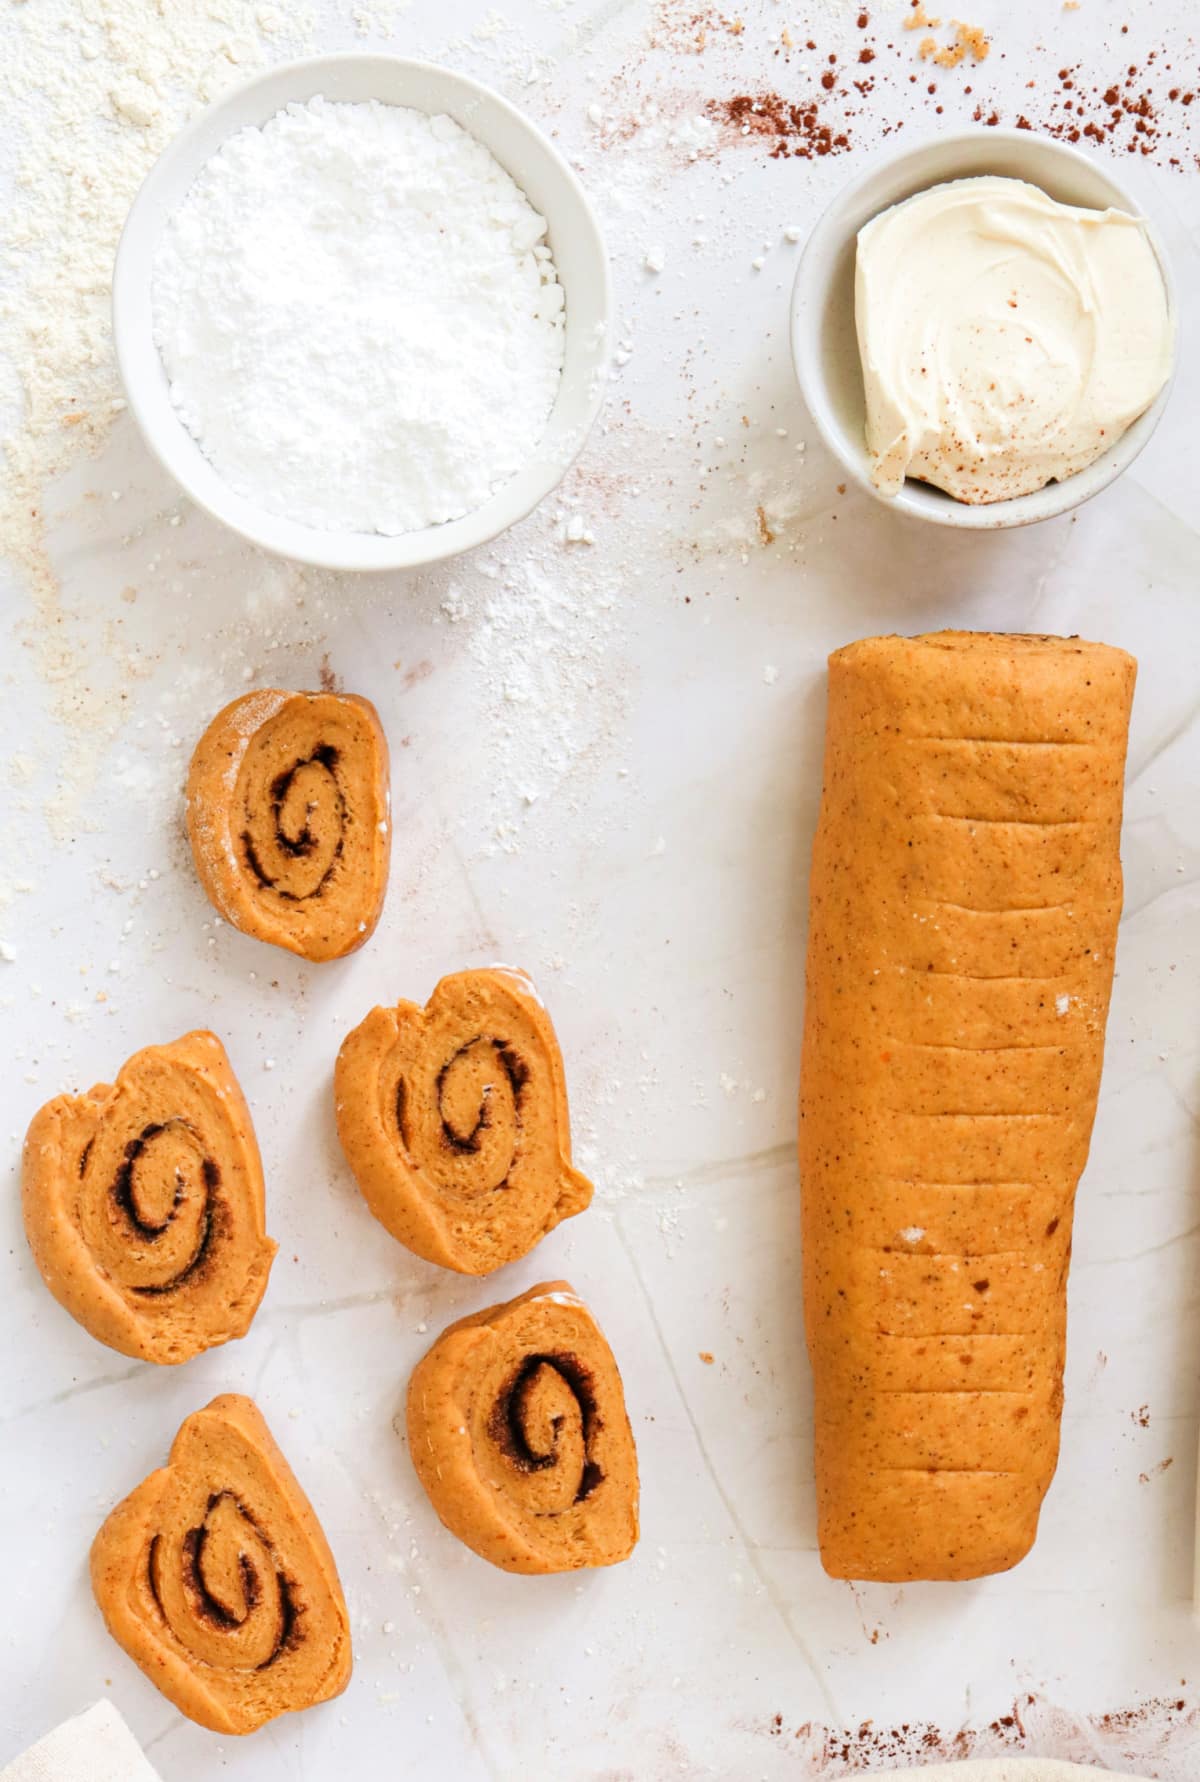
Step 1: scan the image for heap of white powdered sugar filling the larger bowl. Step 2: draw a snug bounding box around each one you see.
[153,96,563,535]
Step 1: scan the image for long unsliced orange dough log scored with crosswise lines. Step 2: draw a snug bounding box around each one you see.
[801,631,1136,1581]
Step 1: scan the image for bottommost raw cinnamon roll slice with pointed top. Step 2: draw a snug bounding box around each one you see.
[91,1394,351,1732]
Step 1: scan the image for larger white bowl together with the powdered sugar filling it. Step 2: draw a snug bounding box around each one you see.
[112,55,610,570]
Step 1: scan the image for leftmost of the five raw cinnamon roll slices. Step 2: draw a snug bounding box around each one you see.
[21,1032,276,1363]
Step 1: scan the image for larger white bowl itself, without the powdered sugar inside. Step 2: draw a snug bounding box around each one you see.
[112,53,612,570]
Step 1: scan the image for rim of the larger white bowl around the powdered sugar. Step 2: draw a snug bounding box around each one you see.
[111,50,613,572]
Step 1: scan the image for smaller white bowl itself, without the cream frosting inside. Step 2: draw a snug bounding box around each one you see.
[792,127,1179,531]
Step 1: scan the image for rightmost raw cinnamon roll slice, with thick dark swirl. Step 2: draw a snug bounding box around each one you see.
[408,1281,638,1572]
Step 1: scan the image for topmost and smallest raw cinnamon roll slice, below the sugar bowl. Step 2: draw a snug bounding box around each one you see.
[187,688,390,960]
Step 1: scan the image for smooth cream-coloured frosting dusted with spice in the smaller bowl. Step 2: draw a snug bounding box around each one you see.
[854,176,1175,503]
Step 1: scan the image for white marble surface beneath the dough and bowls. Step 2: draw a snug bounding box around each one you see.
[0,0,1200,1782]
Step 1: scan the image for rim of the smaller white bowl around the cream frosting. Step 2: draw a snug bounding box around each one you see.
[788,125,1179,531]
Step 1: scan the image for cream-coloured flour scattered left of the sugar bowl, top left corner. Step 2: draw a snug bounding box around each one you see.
[0,0,312,836]
